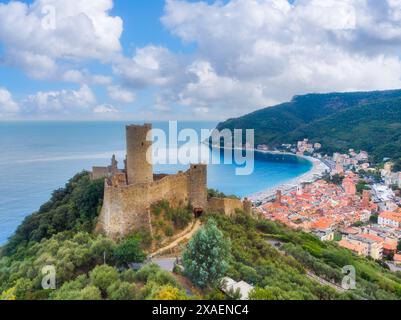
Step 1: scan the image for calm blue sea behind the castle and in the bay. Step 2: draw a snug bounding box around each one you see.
[0,122,311,244]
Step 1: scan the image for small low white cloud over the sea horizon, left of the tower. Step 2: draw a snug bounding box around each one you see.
[23,85,96,114]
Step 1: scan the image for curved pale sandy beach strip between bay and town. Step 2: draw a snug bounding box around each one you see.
[209,144,330,207]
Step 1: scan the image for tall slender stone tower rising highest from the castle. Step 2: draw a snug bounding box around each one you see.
[126,124,153,185]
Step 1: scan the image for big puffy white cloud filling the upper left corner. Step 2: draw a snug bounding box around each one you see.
[0,0,123,78]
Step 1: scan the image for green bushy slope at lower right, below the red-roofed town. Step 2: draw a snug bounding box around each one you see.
[206,213,401,300]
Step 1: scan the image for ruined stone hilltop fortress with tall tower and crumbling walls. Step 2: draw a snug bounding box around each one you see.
[91,124,252,239]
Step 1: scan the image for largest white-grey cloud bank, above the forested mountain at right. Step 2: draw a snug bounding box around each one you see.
[152,0,401,116]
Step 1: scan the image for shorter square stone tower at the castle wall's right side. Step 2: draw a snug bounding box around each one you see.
[188,164,207,211]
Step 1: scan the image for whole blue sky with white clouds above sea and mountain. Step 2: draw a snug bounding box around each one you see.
[0,0,401,121]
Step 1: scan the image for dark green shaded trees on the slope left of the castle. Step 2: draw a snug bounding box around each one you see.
[3,172,104,255]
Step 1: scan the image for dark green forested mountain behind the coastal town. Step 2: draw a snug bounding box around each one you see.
[217,90,401,166]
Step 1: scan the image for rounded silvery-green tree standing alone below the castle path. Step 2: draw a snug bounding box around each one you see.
[183,219,230,288]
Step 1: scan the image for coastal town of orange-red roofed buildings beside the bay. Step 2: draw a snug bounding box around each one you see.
[251,139,401,271]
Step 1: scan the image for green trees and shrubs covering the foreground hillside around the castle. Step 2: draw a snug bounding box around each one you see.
[0,174,401,300]
